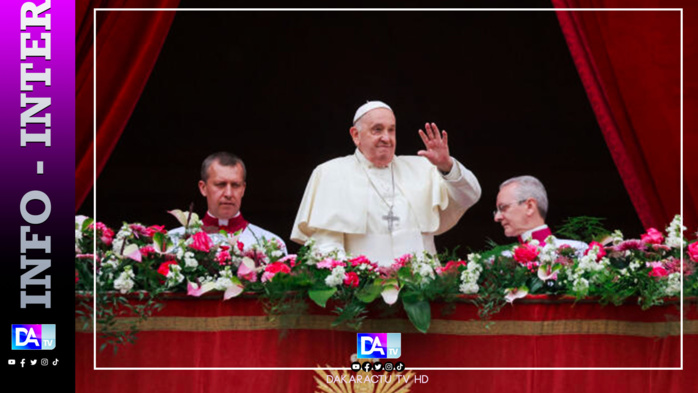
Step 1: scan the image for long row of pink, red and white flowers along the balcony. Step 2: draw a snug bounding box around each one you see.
[75,210,698,345]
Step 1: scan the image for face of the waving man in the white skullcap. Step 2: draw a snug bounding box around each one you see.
[349,108,396,167]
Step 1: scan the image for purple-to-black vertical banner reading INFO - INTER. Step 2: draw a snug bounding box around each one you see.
[0,0,75,386]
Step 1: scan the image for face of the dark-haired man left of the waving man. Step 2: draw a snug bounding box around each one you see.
[199,161,246,220]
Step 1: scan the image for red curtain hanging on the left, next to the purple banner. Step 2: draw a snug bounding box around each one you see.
[75,0,179,210]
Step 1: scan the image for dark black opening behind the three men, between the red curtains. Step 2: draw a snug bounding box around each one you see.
[79,5,643,256]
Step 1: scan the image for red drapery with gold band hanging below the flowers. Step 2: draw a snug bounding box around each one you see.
[76,296,698,393]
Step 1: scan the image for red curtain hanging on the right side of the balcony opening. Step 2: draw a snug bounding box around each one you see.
[552,0,698,230]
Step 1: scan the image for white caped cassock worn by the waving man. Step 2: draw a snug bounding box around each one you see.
[291,149,481,266]
